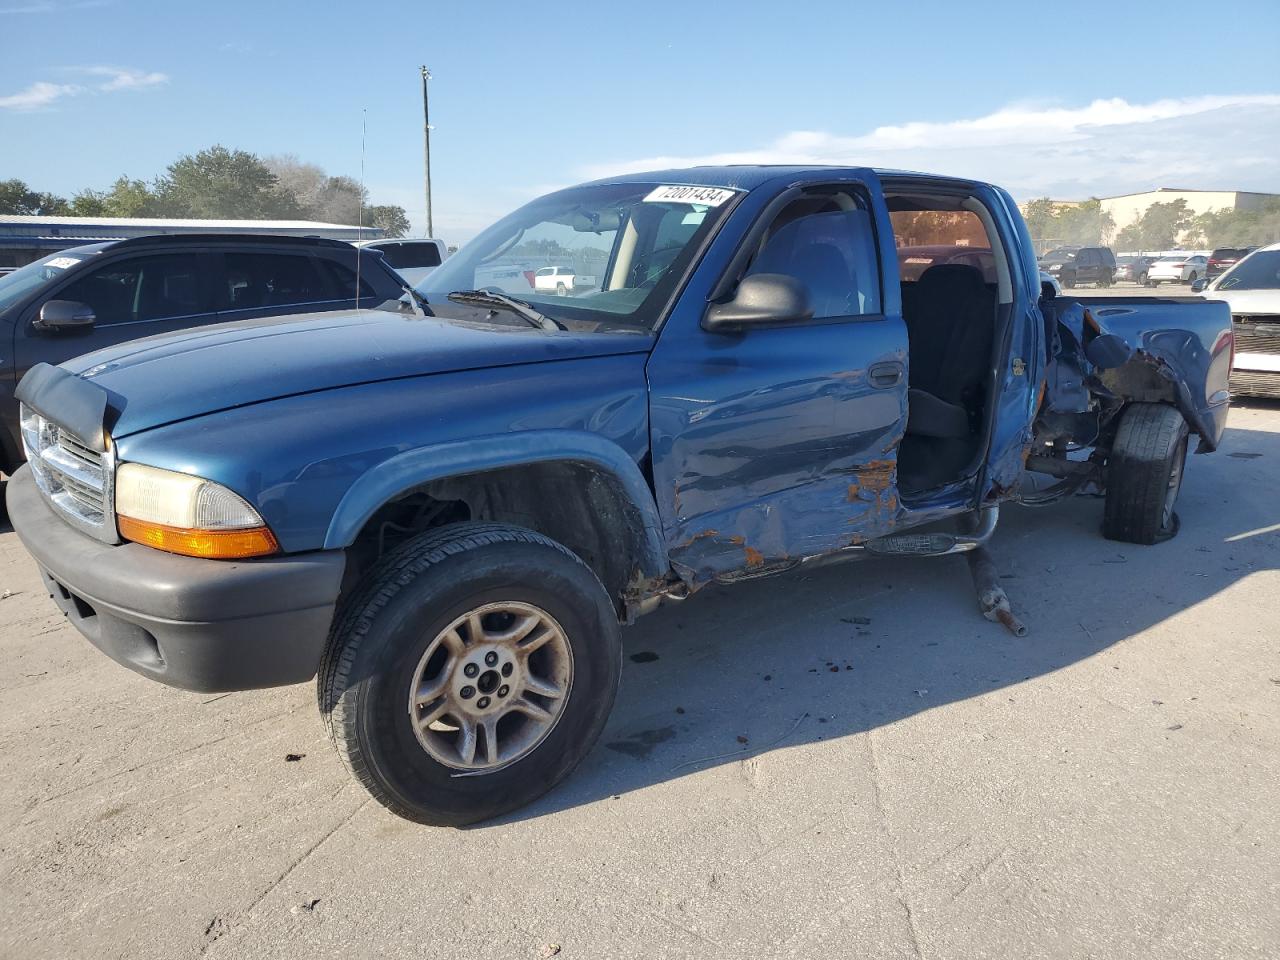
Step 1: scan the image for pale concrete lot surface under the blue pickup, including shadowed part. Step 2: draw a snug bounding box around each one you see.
[0,366,1280,960]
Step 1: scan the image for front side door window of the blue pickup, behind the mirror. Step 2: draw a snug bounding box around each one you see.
[746,191,881,320]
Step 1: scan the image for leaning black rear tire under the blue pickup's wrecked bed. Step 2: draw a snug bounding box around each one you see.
[1102,403,1190,544]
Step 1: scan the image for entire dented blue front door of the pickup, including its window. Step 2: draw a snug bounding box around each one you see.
[648,179,908,582]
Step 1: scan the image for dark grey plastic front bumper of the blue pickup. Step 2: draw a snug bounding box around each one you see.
[6,466,346,692]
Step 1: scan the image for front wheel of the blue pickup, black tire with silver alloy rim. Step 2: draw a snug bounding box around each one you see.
[317,524,622,827]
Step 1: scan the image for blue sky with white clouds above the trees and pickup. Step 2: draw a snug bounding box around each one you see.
[0,0,1280,239]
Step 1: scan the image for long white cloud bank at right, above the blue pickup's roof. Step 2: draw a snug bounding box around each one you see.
[581,93,1280,197]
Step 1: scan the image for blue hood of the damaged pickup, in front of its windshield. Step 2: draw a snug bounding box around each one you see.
[63,310,653,436]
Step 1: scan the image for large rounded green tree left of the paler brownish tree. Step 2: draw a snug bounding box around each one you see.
[156,146,302,220]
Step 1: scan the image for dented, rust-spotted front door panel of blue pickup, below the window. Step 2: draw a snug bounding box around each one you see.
[650,317,906,586]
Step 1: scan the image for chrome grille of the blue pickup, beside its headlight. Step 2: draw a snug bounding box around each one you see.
[22,406,115,541]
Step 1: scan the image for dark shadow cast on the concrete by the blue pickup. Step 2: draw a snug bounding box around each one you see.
[480,419,1280,828]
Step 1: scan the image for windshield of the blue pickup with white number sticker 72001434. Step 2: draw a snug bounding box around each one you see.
[417,183,735,330]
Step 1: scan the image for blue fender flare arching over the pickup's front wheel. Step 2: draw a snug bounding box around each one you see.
[324,430,669,577]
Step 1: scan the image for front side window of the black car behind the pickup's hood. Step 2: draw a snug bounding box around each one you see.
[56,253,204,325]
